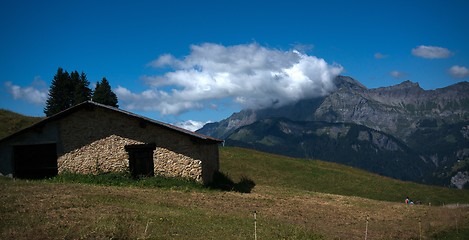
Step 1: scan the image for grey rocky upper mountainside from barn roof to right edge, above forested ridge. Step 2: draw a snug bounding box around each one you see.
[199,76,469,141]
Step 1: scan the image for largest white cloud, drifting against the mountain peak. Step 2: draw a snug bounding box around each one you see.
[115,43,343,114]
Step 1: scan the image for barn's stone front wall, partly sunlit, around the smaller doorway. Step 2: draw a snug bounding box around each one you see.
[58,108,219,183]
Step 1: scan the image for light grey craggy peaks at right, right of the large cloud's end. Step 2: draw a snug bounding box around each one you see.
[314,77,469,142]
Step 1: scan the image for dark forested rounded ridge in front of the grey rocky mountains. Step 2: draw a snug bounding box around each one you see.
[225,118,433,182]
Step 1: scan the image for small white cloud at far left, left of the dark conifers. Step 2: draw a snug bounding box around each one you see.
[5,78,48,105]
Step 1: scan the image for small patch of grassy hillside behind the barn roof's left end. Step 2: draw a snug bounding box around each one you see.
[0,109,43,139]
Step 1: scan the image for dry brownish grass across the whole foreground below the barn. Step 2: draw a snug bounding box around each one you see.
[0,178,469,239]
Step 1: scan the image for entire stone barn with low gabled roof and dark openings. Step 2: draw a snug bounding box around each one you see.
[0,102,222,184]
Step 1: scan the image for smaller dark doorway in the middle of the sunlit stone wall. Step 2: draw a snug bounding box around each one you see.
[125,144,156,177]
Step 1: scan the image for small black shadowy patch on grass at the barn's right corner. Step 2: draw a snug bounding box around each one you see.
[208,171,256,193]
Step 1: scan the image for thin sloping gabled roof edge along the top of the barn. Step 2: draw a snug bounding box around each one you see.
[0,101,223,143]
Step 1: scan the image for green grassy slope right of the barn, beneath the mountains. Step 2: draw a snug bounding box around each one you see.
[220,147,469,205]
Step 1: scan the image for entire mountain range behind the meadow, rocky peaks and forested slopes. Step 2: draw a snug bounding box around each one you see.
[198,76,469,188]
